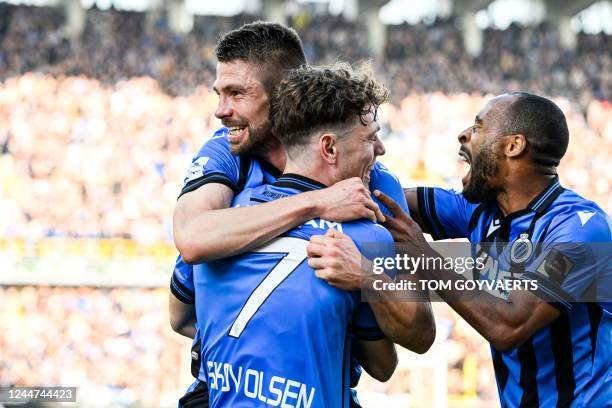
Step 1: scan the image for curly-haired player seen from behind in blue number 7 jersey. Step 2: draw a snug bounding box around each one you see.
[179,64,434,407]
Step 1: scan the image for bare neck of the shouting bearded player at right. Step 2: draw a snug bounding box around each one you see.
[497,174,556,216]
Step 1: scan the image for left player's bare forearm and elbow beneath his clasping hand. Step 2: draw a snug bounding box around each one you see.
[366,275,436,354]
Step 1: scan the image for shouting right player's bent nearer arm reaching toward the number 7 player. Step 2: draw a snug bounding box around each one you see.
[377,194,606,351]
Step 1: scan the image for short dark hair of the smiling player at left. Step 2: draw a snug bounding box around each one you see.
[215,21,307,95]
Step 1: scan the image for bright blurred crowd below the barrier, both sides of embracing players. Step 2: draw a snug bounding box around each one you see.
[0,286,496,407]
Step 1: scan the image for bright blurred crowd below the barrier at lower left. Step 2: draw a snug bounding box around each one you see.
[0,286,189,407]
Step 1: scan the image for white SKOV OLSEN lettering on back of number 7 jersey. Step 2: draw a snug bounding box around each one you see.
[206,361,316,408]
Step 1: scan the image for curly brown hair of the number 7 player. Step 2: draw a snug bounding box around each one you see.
[270,62,388,154]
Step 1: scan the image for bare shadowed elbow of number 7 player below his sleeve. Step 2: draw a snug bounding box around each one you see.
[354,338,397,382]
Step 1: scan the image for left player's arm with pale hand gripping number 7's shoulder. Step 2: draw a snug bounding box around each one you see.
[307,230,436,354]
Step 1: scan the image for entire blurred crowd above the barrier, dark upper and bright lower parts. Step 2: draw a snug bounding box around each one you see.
[0,4,612,244]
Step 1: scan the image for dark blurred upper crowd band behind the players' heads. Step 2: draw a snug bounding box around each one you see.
[0,4,612,108]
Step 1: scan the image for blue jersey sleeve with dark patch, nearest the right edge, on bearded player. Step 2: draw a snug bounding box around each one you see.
[521,212,612,310]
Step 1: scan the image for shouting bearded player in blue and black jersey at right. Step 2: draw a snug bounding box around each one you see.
[312,92,612,407]
